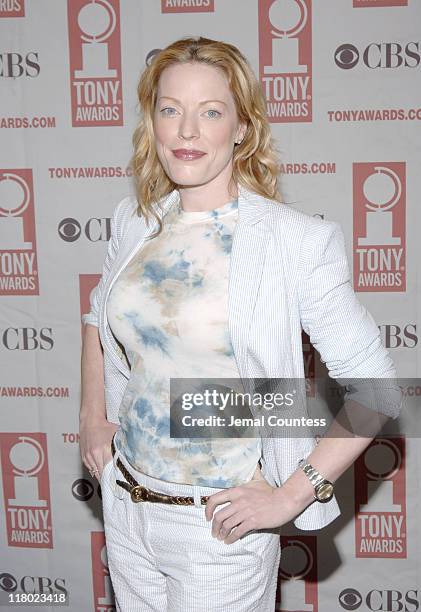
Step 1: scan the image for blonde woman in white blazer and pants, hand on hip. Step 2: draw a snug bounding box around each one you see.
[80,37,399,612]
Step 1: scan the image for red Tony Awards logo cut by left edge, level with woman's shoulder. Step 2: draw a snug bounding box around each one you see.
[0,170,39,295]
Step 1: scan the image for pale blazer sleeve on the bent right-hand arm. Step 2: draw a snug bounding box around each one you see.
[298,218,402,418]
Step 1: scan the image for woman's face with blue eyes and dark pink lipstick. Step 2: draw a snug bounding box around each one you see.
[153,62,246,187]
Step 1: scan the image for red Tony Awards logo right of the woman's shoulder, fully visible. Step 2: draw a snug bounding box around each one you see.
[354,162,405,291]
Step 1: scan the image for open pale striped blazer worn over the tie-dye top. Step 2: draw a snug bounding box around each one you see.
[82,185,396,530]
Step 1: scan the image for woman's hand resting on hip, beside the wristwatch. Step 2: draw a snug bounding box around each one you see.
[205,479,304,544]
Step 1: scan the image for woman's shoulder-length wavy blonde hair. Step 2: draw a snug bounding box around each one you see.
[130,36,281,237]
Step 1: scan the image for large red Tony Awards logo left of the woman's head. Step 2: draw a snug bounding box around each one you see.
[68,0,123,126]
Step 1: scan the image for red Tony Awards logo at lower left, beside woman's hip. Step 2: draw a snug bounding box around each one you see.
[1,433,53,548]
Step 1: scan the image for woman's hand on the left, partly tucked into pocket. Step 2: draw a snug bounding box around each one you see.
[79,417,119,481]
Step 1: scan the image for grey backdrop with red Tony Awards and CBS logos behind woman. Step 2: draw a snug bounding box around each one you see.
[0,0,421,612]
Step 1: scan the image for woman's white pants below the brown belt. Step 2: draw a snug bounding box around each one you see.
[101,440,281,612]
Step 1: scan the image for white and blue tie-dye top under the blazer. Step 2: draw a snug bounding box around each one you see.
[107,200,261,488]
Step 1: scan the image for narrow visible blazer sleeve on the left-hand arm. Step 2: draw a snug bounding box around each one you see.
[82,198,130,327]
